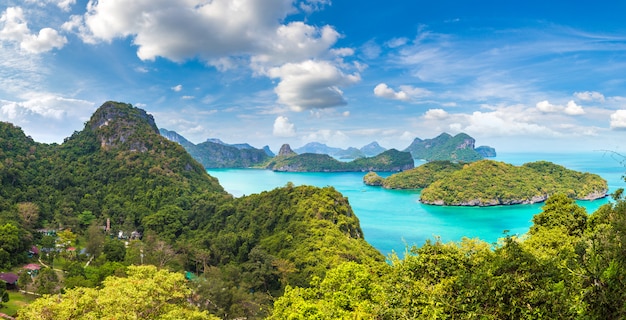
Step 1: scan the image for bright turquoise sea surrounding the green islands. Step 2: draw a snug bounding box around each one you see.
[208,152,626,256]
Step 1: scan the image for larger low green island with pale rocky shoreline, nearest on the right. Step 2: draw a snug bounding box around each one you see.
[420,160,608,206]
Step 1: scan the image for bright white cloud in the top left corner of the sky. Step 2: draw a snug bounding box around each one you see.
[0,7,67,54]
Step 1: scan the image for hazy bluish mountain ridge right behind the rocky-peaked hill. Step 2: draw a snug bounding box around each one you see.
[159,129,273,168]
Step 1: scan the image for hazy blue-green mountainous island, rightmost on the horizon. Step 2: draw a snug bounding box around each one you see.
[404,133,495,162]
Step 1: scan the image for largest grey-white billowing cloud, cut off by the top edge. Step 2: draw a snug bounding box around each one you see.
[68,0,339,64]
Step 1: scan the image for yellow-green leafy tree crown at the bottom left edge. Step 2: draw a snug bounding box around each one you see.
[18,266,217,320]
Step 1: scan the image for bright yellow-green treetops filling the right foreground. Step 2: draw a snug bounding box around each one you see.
[270,194,626,319]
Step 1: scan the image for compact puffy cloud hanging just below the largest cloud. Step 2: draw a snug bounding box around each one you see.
[268,60,361,111]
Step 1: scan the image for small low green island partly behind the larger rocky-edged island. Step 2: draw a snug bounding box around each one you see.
[363,161,463,189]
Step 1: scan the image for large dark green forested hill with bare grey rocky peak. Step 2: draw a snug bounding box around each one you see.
[0,102,384,319]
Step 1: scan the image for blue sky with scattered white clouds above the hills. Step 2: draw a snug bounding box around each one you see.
[0,0,626,153]
